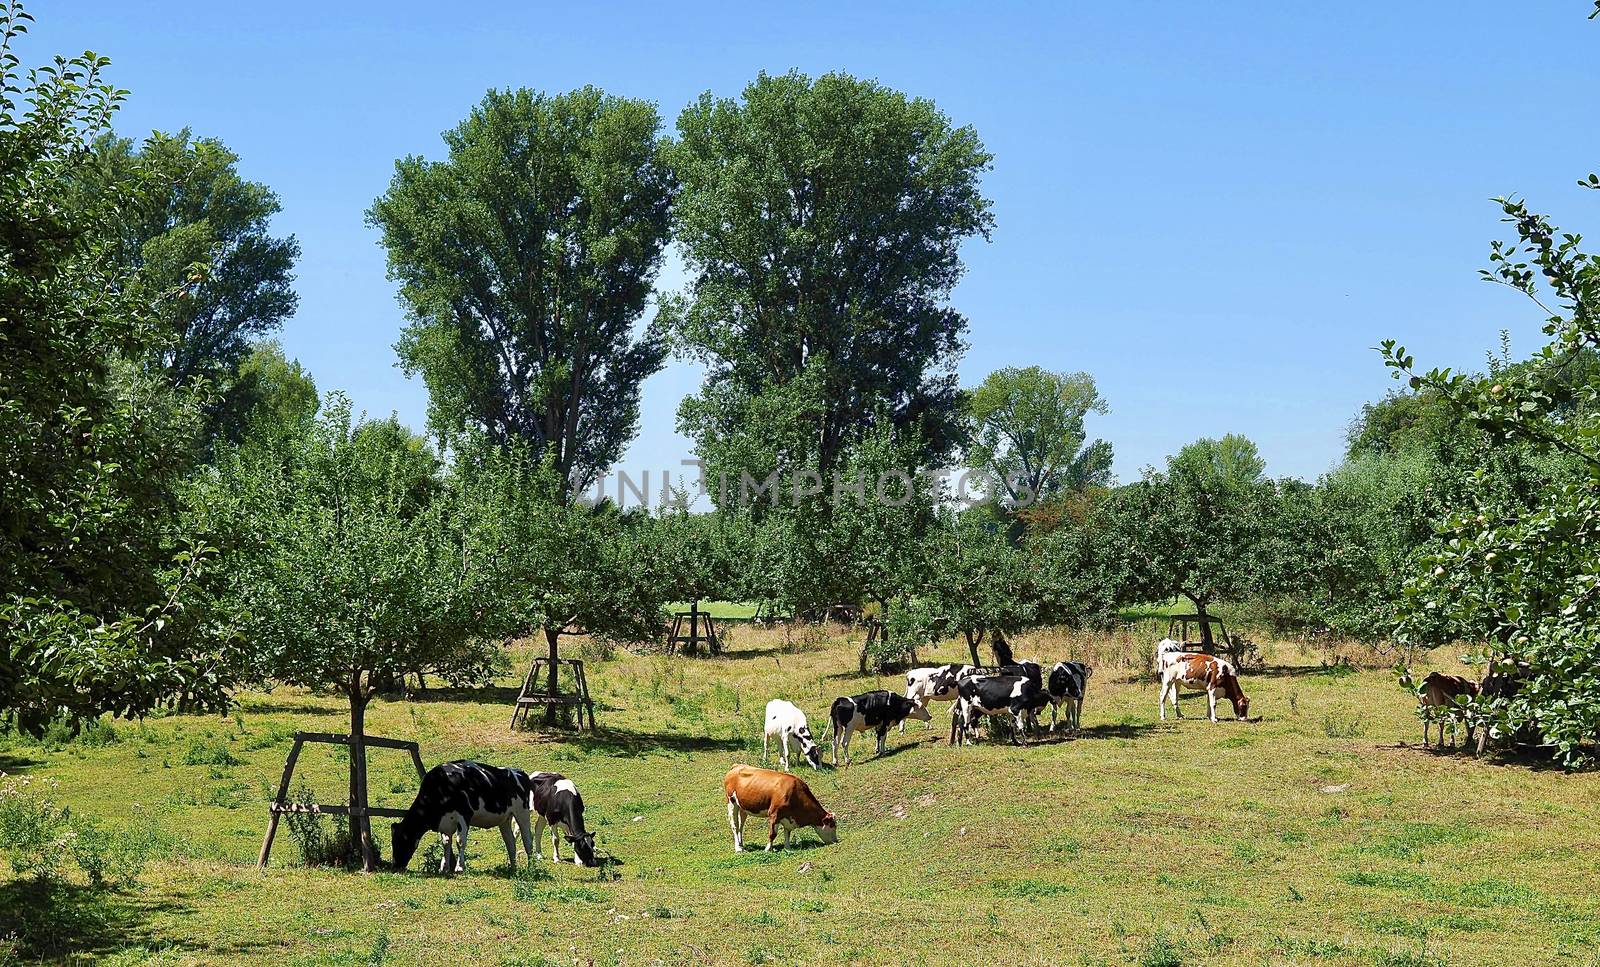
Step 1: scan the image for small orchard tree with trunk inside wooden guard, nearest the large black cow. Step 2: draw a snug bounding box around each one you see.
[197,394,498,871]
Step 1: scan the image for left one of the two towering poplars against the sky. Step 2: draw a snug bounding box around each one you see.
[366,86,672,495]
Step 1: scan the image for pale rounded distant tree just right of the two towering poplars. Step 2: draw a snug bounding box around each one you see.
[966,367,1112,506]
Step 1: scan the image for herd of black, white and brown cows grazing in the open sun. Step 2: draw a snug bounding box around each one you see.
[390,639,1250,873]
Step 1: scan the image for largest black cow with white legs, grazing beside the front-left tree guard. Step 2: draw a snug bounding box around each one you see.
[389,760,534,873]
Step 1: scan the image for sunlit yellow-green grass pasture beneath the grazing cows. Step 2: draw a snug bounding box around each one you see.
[0,626,1600,967]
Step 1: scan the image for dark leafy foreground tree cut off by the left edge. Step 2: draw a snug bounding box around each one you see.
[0,0,226,733]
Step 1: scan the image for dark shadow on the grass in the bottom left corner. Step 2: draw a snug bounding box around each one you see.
[0,877,184,962]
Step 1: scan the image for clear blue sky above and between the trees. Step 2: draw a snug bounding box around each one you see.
[21,0,1600,480]
